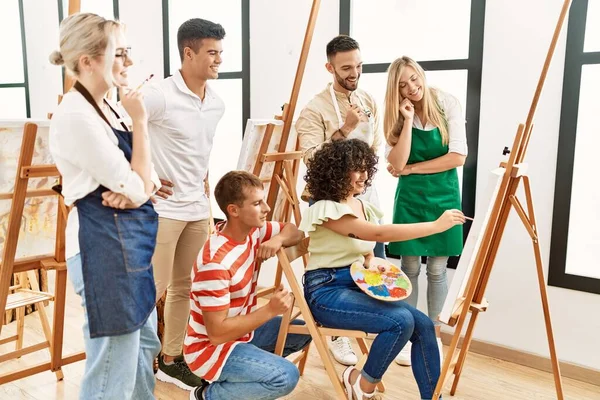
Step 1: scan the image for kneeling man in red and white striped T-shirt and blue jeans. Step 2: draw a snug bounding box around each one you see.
[184,171,311,400]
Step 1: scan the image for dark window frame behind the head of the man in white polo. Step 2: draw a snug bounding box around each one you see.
[162,0,250,137]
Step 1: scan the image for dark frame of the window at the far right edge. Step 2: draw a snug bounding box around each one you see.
[548,0,600,294]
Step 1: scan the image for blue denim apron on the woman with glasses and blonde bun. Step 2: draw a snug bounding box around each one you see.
[74,82,158,338]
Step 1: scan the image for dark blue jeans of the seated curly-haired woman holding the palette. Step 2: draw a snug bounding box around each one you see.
[304,267,440,399]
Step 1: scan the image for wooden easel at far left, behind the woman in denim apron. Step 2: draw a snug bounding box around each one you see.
[0,123,85,384]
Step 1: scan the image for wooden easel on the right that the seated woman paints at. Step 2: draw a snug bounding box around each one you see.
[433,0,571,400]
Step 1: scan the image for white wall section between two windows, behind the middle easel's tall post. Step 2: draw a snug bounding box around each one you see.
[250,0,339,118]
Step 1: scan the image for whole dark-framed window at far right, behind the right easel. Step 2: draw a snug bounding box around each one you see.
[548,0,600,294]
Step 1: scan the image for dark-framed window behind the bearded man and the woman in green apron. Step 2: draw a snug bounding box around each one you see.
[340,0,485,266]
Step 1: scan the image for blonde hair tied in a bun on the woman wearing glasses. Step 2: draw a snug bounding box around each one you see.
[49,13,122,82]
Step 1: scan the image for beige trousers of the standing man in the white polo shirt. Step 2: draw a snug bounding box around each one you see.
[152,217,209,356]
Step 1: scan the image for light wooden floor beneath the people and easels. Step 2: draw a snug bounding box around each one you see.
[0,278,600,400]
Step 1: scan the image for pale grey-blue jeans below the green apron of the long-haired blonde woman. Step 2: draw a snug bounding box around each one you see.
[401,256,448,325]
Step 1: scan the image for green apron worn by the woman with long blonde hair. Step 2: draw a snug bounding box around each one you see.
[388,128,463,257]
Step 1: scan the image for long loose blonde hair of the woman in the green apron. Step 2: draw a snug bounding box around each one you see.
[383,56,448,146]
